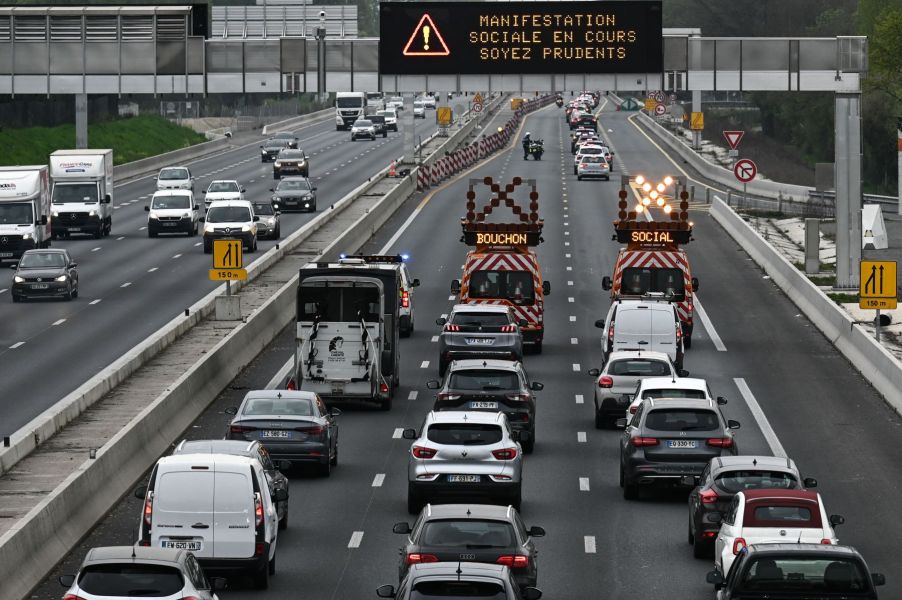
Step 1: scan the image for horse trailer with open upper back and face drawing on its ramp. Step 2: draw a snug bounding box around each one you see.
[290,259,401,410]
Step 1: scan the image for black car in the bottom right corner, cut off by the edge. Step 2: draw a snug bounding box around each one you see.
[707,544,886,600]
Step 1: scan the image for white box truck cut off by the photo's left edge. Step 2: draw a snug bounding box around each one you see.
[0,165,50,260]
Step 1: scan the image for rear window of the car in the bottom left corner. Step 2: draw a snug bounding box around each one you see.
[78,563,185,598]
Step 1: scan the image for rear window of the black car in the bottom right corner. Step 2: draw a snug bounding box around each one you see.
[737,552,872,598]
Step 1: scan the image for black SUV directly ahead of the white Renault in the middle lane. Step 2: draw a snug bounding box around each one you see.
[426,359,545,454]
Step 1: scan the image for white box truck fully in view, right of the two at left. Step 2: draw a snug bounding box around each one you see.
[50,149,113,238]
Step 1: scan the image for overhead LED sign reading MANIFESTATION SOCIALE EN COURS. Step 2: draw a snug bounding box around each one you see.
[379,0,663,75]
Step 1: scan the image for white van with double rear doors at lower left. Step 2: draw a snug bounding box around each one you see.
[135,454,287,589]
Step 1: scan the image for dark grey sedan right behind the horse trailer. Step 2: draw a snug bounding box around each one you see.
[226,390,341,477]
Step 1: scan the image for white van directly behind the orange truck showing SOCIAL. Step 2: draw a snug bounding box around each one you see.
[595,298,683,369]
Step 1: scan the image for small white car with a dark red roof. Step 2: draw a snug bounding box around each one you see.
[714,489,845,577]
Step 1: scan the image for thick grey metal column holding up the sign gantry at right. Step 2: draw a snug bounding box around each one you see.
[835,93,861,287]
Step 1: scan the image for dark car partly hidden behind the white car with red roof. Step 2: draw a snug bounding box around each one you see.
[684,456,817,558]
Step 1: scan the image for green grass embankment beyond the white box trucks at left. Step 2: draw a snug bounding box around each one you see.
[0,115,206,166]
